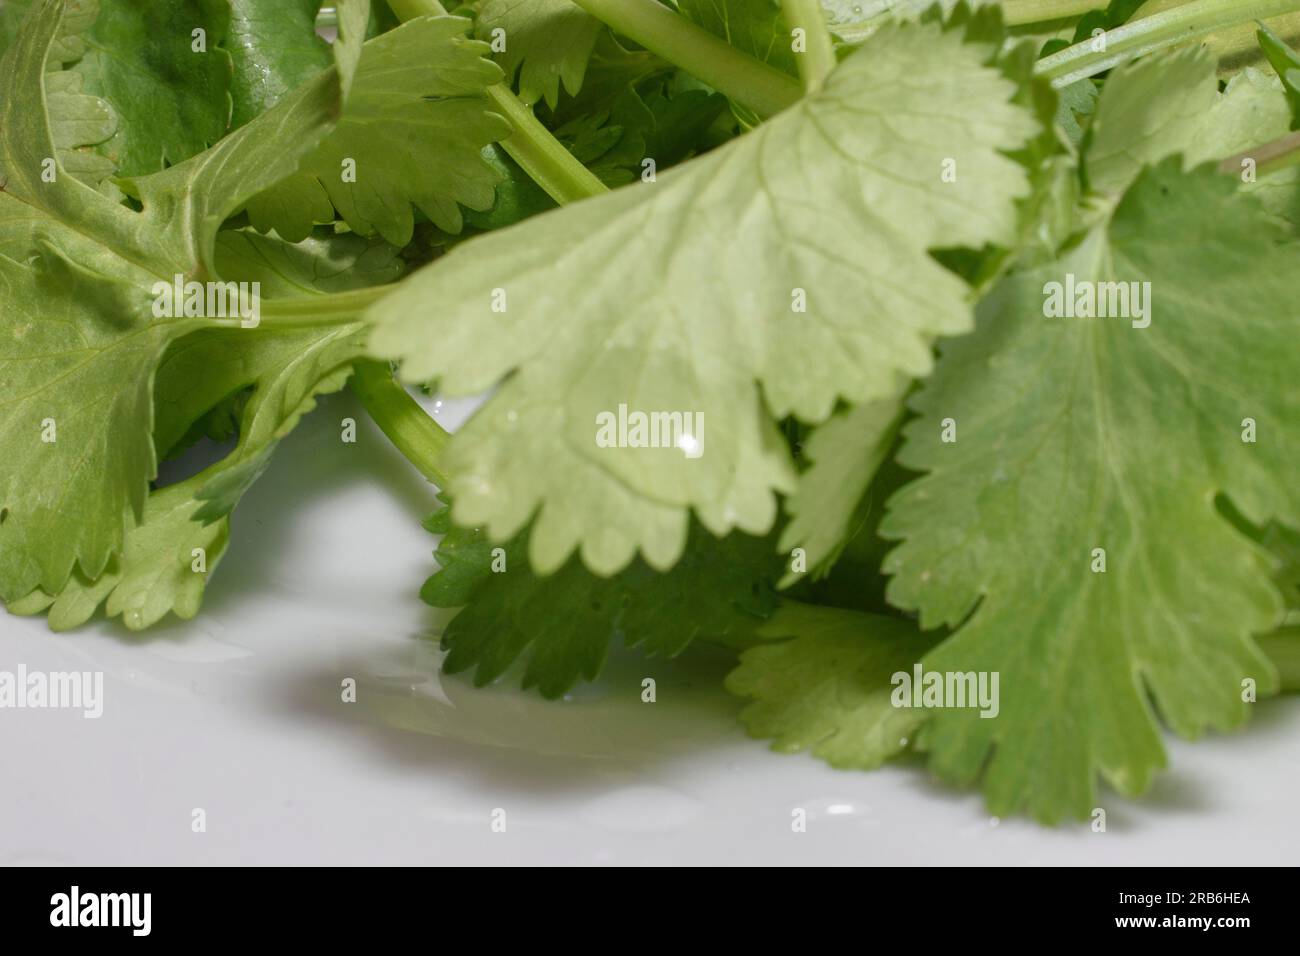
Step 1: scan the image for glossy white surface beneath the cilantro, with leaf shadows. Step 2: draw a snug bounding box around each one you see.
[0,395,1300,865]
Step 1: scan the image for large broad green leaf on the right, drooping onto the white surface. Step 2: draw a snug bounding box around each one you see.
[881,158,1300,822]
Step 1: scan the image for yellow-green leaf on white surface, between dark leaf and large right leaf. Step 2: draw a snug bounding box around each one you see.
[727,604,935,770]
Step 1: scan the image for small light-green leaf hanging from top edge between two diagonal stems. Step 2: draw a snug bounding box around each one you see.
[476,0,601,109]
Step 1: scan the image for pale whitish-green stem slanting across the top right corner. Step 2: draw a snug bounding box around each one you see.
[1036,0,1300,87]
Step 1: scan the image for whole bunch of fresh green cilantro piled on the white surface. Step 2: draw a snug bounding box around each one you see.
[0,0,1300,823]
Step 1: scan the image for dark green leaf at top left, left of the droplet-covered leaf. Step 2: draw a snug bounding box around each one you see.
[74,0,230,176]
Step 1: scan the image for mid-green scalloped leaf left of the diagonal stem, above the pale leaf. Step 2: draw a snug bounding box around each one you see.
[248,17,510,246]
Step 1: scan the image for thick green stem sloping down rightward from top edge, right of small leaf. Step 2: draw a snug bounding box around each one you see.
[573,0,802,117]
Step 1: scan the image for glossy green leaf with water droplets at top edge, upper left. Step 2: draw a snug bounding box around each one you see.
[222,0,332,129]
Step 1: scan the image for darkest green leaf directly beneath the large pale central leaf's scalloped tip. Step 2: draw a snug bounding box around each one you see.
[420,509,780,697]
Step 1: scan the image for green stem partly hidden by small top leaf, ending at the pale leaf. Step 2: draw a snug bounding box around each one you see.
[389,0,607,206]
